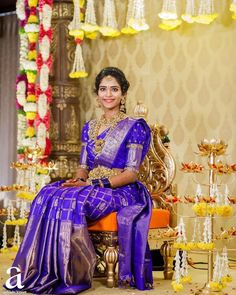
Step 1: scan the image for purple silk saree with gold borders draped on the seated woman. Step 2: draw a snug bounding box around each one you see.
[5,117,153,294]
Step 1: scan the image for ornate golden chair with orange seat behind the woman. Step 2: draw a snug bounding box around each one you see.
[88,119,175,287]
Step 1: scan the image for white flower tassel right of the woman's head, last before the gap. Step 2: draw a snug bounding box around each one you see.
[128,0,149,32]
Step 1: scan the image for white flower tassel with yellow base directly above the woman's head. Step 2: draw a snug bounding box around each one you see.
[99,0,120,37]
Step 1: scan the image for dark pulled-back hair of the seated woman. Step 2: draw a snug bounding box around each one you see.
[95,67,129,95]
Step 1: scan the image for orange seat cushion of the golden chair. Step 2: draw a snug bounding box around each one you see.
[88,208,170,231]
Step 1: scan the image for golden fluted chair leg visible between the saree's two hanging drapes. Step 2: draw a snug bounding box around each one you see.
[104,246,118,288]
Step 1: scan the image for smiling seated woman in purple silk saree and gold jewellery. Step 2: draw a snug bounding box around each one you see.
[6,67,153,294]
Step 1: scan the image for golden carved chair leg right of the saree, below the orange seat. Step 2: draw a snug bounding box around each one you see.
[160,241,175,280]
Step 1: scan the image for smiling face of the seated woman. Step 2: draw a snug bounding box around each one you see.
[98,76,124,111]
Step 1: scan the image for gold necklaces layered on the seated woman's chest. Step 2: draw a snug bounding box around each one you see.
[88,112,127,155]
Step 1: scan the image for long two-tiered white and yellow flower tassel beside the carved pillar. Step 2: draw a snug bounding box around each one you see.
[68,0,88,78]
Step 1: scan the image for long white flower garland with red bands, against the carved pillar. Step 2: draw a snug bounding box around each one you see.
[35,0,53,155]
